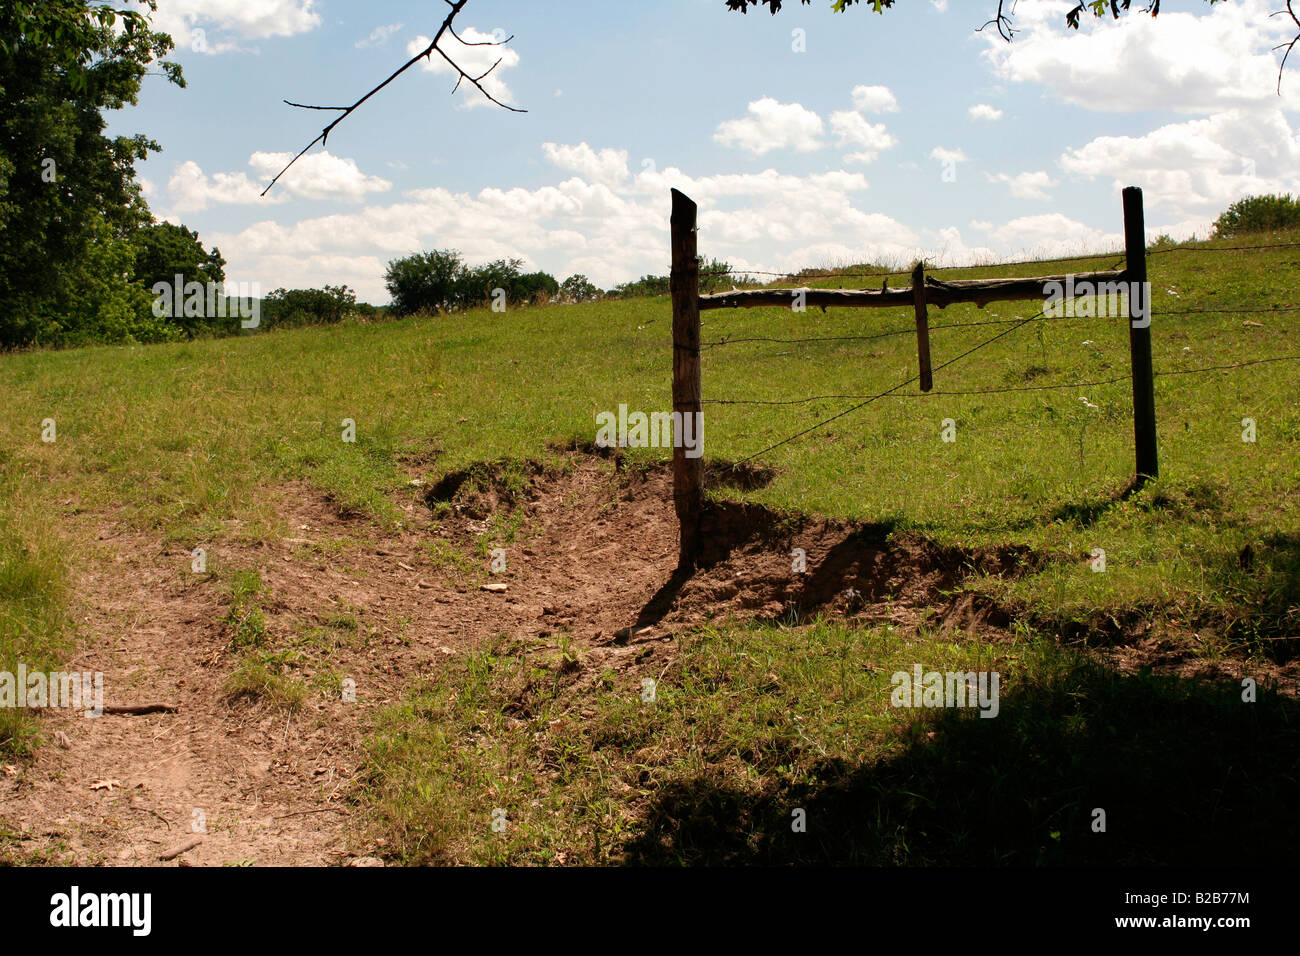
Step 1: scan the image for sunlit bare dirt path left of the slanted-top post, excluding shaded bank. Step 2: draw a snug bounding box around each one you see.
[0,463,702,865]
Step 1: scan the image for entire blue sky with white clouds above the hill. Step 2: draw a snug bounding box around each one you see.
[109,0,1300,304]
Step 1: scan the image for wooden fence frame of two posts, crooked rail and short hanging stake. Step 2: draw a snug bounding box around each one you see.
[671,186,1160,571]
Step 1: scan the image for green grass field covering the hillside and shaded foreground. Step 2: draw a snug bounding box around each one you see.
[0,234,1300,862]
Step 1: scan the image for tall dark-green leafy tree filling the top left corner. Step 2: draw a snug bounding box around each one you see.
[0,0,185,347]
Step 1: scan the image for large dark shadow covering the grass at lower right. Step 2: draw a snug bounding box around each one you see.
[624,659,1300,865]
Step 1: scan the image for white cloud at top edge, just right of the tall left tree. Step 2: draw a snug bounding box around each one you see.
[152,0,321,53]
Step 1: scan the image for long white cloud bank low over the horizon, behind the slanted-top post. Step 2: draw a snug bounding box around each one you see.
[195,134,1138,302]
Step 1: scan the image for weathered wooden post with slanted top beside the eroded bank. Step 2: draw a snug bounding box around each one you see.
[670,190,705,571]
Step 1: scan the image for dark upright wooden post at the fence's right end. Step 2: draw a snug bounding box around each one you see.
[1123,186,1160,489]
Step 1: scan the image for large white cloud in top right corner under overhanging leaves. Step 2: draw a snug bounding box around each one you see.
[984,0,1295,113]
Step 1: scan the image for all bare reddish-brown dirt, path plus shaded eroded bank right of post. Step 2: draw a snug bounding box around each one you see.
[0,458,1289,865]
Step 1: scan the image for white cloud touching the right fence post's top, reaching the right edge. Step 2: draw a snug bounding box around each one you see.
[1060,109,1300,221]
